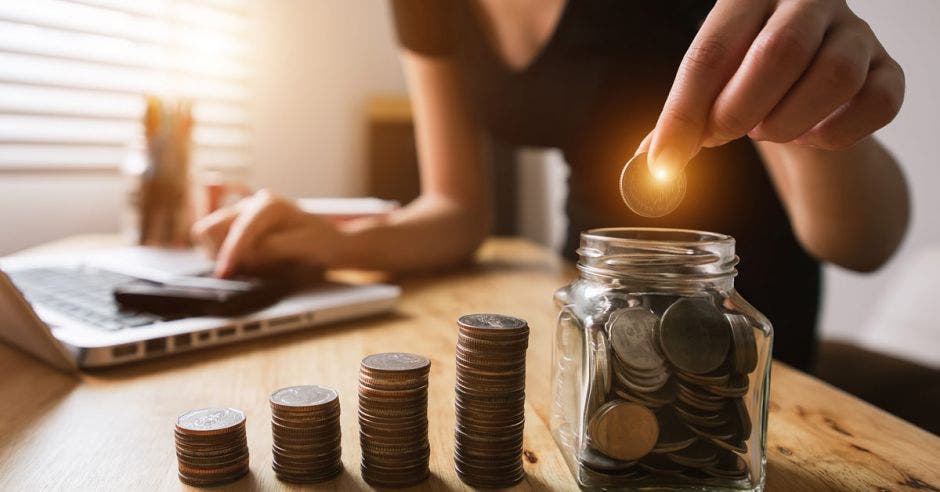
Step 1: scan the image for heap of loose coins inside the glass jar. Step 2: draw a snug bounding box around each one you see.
[578,296,758,483]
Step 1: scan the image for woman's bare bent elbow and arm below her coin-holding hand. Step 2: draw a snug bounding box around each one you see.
[758,137,910,272]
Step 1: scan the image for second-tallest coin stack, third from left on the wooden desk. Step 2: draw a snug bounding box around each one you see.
[359,352,431,487]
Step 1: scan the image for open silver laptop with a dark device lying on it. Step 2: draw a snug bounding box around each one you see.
[0,247,401,371]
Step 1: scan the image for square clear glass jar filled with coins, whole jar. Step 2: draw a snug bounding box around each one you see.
[551,228,773,490]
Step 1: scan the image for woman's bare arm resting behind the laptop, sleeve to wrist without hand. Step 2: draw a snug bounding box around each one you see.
[336,51,490,270]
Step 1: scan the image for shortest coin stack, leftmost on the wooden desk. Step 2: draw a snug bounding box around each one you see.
[175,408,248,487]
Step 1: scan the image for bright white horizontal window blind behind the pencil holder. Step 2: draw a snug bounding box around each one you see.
[0,0,252,170]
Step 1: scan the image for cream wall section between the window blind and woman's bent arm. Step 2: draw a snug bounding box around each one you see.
[253,0,406,196]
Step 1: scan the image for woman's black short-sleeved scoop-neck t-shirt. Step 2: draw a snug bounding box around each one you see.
[392,0,820,369]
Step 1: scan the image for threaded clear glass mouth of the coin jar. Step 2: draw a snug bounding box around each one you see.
[578,227,738,283]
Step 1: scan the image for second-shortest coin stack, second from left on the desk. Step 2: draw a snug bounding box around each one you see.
[270,385,343,483]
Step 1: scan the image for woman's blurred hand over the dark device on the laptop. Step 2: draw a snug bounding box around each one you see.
[192,190,341,277]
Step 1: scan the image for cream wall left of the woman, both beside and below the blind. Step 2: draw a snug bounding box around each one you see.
[0,0,405,254]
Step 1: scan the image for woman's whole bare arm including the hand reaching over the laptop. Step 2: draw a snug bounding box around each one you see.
[193,52,490,277]
